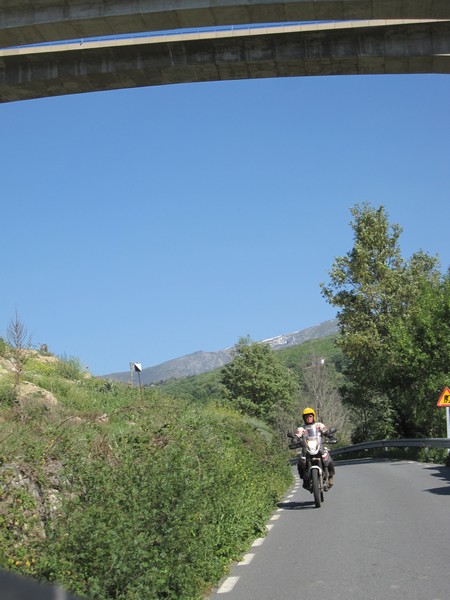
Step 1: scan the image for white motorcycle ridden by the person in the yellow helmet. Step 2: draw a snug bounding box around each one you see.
[288,423,336,508]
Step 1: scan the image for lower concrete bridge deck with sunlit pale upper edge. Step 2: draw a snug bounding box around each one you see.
[0,21,450,102]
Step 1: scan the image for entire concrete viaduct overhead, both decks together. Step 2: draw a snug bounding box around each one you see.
[0,0,450,102]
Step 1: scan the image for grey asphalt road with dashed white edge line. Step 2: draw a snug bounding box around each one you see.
[209,460,450,600]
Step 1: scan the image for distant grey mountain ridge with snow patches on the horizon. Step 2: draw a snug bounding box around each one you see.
[102,319,338,385]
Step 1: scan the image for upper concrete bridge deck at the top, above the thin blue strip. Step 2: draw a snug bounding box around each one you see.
[0,0,450,47]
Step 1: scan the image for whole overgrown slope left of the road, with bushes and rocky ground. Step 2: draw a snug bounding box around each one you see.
[0,345,291,600]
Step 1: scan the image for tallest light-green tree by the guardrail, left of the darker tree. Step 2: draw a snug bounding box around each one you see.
[322,203,441,441]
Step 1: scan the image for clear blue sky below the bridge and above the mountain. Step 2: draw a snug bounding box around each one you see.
[0,75,450,375]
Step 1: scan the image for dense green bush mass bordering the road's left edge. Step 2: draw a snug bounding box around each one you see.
[34,400,291,600]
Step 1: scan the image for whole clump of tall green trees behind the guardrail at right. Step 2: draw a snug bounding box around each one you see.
[321,203,450,441]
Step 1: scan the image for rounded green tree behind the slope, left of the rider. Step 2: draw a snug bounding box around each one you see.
[221,337,298,423]
